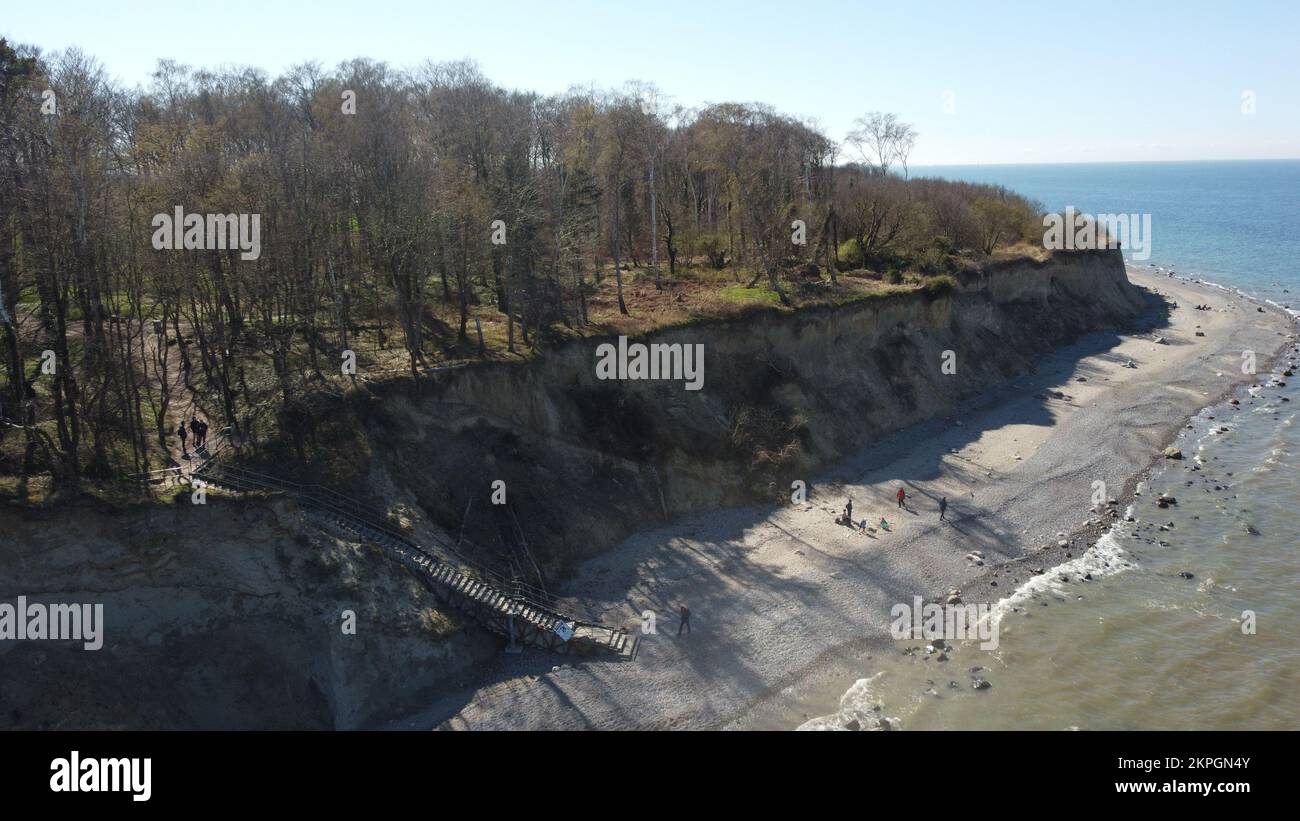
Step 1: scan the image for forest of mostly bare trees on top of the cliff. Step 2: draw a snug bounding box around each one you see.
[0,40,1041,499]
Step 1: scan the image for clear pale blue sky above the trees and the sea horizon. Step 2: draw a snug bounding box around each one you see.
[0,0,1300,165]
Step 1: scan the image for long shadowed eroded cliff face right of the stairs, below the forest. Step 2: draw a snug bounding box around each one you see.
[363,251,1148,578]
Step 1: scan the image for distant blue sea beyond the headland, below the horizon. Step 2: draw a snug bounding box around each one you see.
[913,160,1300,308]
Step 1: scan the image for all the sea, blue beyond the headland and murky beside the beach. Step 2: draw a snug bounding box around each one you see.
[785,160,1300,730]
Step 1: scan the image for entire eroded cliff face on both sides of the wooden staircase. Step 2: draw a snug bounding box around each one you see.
[0,252,1149,727]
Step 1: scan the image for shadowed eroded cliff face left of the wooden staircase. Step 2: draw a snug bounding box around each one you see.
[0,494,498,729]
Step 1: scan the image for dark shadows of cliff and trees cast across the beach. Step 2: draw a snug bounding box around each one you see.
[424,285,1171,729]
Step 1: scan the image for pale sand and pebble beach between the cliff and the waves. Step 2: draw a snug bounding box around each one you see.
[400,269,1295,729]
